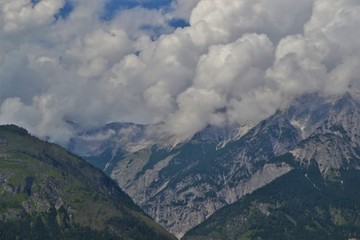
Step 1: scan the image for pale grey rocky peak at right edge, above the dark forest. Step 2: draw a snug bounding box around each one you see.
[291,94,360,177]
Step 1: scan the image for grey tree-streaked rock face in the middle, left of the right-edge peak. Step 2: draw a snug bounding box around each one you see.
[111,112,302,237]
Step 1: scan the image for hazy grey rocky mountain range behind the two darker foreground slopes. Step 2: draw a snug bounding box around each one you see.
[68,93,360,239]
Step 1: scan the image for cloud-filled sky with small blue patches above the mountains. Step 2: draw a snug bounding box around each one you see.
[0,0,360,145]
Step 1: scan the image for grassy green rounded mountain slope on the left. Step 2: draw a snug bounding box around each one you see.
[0,125,174,239]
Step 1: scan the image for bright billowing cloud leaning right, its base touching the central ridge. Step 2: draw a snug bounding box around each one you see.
[168,33,273,135]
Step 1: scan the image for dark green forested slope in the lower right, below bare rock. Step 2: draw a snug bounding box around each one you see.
[183,158,360,240]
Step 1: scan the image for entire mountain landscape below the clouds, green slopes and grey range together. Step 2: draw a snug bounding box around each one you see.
[0,93,360,240]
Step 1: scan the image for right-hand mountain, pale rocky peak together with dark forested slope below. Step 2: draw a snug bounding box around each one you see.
[184,94,360,239]
